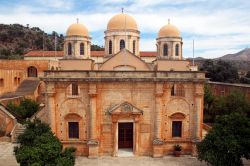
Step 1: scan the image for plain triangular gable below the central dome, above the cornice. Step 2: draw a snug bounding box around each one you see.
[99,49,150,71]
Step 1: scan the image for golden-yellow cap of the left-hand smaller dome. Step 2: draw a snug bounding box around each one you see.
[66,23,89,36]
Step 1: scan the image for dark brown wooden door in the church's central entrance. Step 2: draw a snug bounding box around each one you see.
[118,123,133,148]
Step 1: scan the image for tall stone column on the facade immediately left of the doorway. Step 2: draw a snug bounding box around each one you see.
[88,84,99,158]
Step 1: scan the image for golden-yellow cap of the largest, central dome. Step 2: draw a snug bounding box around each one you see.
[107,13,138,30]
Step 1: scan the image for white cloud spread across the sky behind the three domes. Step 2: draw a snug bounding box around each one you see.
[0,0,250,57]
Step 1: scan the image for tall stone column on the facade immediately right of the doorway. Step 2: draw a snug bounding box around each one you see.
[153,83,164,157]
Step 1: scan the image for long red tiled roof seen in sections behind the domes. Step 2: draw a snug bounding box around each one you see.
[24,51,157,57]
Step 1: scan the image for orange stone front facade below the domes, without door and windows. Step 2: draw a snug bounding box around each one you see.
[43,71,205,157]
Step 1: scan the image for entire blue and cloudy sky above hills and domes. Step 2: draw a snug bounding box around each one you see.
[0,0,250,58]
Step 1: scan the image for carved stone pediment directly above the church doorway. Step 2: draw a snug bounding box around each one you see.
[107,102,143,115]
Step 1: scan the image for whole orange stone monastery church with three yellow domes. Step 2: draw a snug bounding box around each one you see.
[0,13,206,158]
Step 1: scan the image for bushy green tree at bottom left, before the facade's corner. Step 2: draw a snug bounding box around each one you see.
[14,119,75,166]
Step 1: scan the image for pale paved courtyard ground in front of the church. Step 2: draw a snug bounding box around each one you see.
[0,142,250,166]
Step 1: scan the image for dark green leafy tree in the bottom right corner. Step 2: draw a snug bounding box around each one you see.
[197,112,250,166]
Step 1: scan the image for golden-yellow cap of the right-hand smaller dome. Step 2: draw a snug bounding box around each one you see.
[158,24,181,37]
